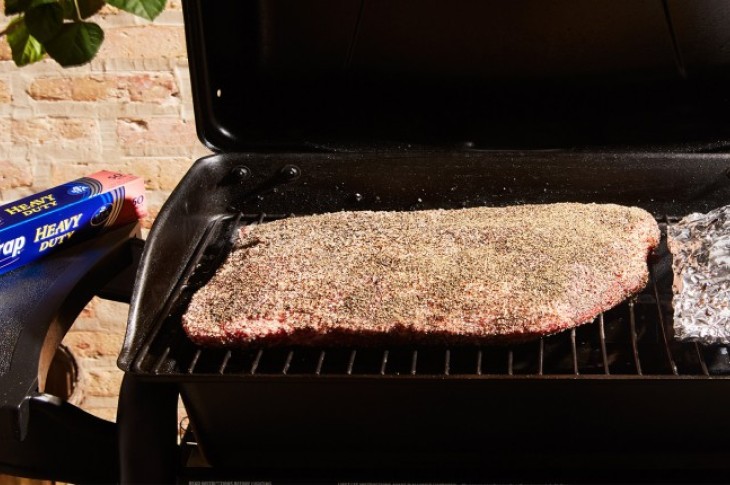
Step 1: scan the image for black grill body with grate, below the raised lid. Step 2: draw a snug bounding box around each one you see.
[120,152,730,480]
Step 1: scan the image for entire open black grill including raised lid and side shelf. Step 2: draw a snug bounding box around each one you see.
[0,0,730,483]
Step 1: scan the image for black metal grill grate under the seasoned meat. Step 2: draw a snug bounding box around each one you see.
[135,214,730,378]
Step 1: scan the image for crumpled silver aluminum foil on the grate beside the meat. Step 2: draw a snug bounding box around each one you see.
[667,205,730,344]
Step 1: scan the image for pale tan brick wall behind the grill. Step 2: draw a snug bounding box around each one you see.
[0,0,208,420]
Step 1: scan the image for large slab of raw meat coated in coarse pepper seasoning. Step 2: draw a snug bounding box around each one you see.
[183,203,660,346]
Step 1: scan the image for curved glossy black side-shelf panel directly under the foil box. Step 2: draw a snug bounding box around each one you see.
[0,224,139,439]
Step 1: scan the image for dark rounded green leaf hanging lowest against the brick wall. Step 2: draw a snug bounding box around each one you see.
[45,22,104,67]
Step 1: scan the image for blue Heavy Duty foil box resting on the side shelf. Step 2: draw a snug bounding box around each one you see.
[0,171,146,274]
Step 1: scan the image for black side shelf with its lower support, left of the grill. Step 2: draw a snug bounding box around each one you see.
[0,223,144,483]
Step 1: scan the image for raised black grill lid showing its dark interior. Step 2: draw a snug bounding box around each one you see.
[179,0,730,151]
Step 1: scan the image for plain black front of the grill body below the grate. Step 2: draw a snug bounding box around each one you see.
[182,376,729,481]
